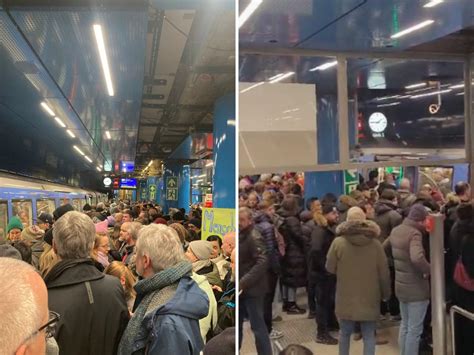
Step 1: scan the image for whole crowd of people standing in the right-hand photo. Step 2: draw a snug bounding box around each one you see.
[239,170,474,355]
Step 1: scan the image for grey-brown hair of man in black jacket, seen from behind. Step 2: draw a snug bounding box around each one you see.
[53,211,95,259]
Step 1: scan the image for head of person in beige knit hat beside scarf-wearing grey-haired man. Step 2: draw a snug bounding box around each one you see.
[184,240,223,289]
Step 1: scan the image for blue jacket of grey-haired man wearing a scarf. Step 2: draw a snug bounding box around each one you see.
[133,277,209,355]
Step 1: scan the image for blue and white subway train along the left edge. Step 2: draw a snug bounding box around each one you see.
[0,174,107,239]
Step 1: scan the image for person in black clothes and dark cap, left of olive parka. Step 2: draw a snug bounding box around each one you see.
[308,203,339,345]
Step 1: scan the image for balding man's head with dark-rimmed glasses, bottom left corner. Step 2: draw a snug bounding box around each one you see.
[0,258,59,355]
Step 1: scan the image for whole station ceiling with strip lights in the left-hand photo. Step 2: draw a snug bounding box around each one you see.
[0,0,235,185]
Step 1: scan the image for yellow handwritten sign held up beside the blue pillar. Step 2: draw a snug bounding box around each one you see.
[201,208,236,239]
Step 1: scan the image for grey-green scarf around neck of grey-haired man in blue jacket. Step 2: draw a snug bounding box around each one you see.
[118,261,192,355]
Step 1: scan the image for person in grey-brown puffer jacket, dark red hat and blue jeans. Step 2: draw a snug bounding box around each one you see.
[384,204,430,355]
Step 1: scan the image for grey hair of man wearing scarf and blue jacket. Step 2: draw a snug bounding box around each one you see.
[136,224,187,273]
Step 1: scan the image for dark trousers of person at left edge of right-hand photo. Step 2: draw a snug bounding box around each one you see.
[239,296,272,355]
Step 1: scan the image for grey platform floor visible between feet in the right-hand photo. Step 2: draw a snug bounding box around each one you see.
[240,290,440,355]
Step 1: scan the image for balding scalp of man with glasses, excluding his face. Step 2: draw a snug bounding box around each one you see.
[0,258,41,354]
